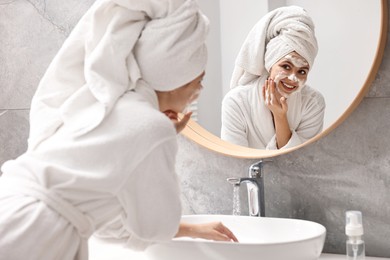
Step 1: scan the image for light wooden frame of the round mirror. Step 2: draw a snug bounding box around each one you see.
[181,0,388,159]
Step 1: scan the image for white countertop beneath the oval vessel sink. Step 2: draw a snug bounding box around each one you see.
[89,237,390,260]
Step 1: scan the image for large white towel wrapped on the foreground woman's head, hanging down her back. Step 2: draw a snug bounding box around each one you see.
[29,0,208,149]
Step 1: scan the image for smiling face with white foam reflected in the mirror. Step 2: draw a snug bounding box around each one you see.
[270,52,309,98]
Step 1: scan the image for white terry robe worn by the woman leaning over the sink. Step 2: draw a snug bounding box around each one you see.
[0,88,181,260]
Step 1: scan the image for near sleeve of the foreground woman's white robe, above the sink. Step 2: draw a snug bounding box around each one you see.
[98,139,181,250]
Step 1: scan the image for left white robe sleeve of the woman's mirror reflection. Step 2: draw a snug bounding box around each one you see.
[221,93,249,147]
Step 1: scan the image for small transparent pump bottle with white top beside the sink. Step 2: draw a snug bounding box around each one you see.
[345,210,366,260]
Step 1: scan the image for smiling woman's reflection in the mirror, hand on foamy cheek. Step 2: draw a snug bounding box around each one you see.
[221,6,325,149]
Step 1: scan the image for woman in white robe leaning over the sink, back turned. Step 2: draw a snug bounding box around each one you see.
[0,0,237,260]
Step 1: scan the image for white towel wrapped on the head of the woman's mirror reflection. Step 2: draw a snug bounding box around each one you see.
[230,6,318,88]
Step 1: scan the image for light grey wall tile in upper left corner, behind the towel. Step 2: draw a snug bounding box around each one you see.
[0,0,94,109]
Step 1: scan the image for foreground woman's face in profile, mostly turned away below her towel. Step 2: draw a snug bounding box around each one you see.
[157,72,205,113]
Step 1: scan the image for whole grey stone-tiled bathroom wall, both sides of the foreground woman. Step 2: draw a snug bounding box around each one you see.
[0,0,390,257]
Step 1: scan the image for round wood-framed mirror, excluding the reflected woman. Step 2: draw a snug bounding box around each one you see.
[182,0,387,158]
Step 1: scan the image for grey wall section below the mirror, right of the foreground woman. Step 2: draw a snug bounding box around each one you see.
[177,25,390,257]
